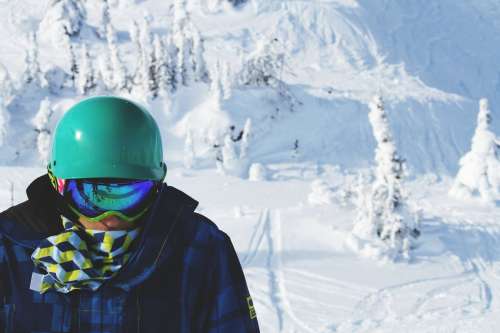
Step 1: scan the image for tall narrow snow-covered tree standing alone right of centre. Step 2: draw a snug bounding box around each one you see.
[353,96,420,258]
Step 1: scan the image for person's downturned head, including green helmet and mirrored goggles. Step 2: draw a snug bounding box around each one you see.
[48,96,167,230]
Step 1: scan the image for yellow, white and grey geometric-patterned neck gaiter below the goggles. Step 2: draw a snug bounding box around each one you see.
[31,217,140,294]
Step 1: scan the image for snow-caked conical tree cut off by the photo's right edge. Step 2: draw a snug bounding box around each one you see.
[449,99,500,202]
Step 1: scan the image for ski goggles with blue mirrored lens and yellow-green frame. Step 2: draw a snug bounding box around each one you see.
[48,172,160,222]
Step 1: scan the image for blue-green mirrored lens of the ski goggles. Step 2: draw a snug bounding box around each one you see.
[63,179,156,217]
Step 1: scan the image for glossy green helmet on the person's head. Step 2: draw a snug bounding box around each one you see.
[48,96,167,181]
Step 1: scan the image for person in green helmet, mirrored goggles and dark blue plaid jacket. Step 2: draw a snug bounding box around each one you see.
[0,97,259,333]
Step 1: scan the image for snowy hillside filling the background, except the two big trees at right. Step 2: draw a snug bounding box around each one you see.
[0,0,500,333]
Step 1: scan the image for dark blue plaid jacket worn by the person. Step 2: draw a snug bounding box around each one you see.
[0,180,259,333]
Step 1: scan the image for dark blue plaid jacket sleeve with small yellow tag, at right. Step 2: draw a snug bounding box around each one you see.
[204,234,260,333]
